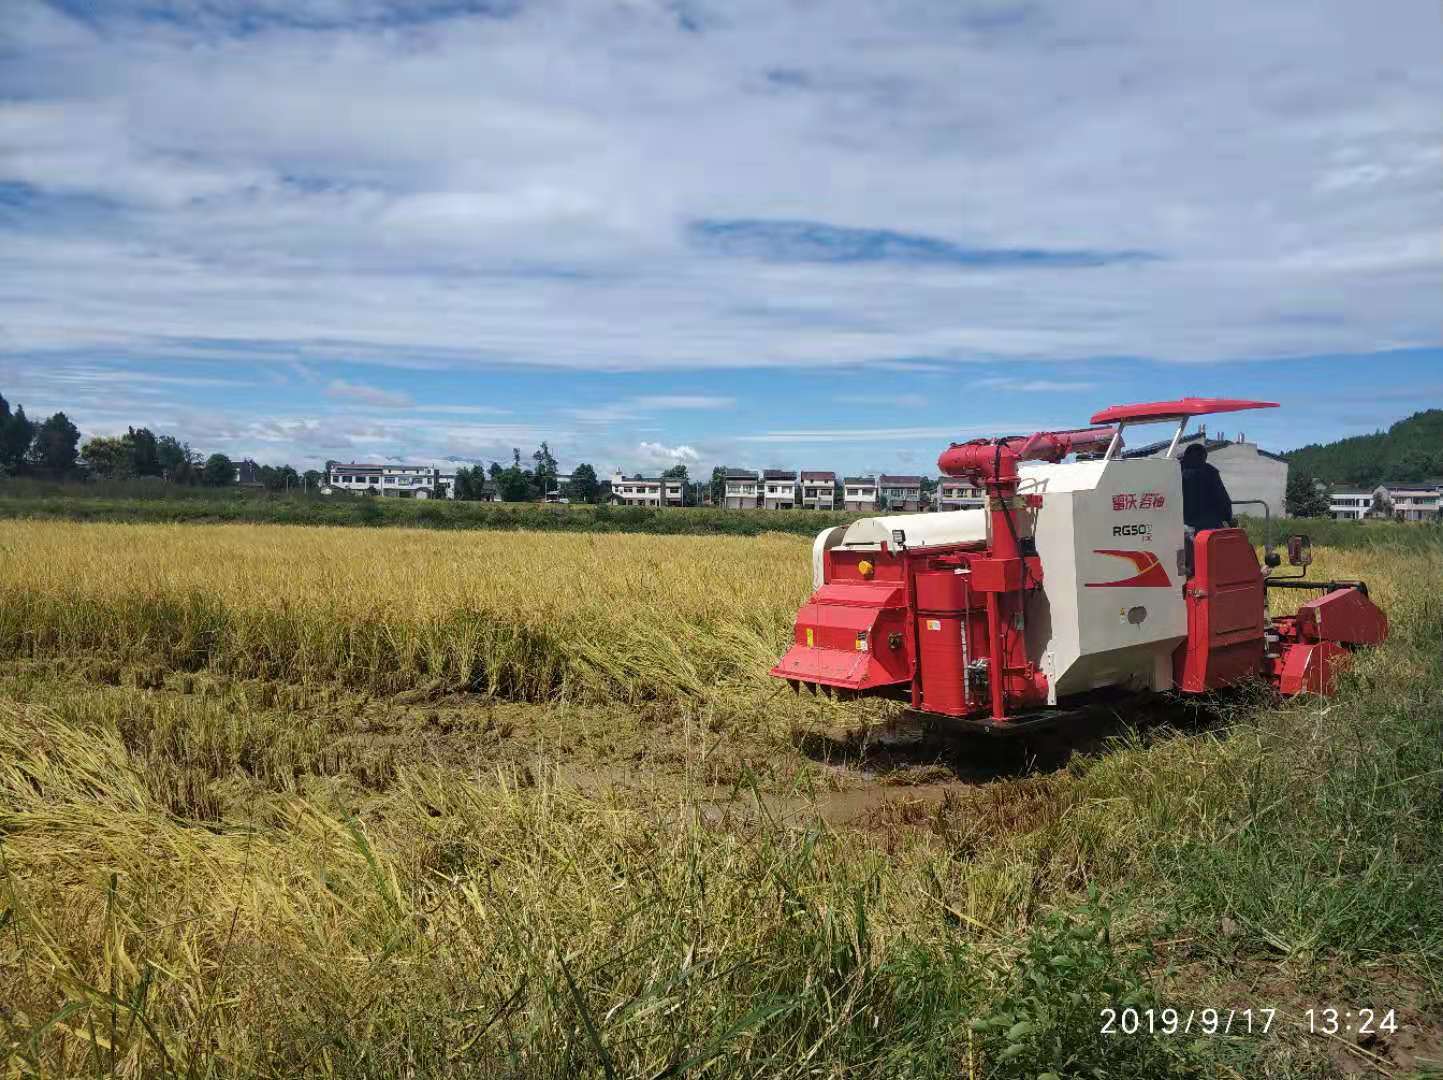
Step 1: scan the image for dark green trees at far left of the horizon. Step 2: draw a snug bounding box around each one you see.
[0,396,320,491]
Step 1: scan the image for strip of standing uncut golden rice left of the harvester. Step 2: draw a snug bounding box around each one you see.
[0,521,810,700]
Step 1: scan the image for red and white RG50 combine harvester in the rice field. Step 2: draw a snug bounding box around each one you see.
[772,397,1388,731]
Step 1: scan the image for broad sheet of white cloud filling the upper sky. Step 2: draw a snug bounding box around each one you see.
[0,0,1443,378]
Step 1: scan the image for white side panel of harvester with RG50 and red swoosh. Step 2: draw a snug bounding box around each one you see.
[1019,458,1188,705]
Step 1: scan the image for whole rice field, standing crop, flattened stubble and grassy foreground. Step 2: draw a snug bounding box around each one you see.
[0,521,1443,1077]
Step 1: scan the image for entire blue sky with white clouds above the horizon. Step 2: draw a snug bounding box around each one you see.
[0,0,1443,474]
